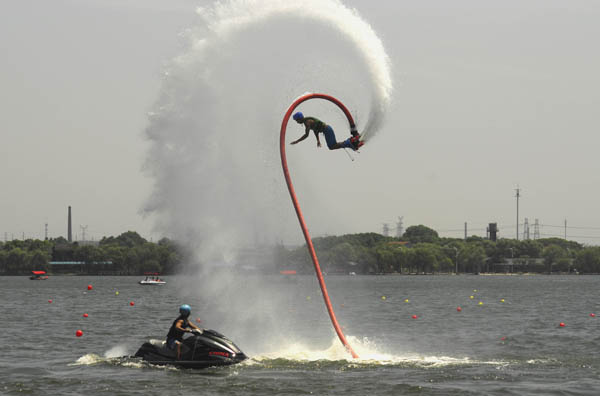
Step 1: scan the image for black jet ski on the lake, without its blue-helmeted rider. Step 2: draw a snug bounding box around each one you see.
[135,329,248,368]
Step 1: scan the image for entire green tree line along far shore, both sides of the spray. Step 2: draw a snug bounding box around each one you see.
[0,225,600,275]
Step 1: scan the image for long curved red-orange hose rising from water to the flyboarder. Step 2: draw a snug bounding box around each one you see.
[279,93,358,358]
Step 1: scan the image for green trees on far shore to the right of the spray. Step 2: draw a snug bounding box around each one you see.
[277,225,600,274]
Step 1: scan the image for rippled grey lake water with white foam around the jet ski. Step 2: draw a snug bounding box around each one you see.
[0,275,600,396]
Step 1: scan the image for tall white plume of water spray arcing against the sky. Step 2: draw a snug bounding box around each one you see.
[145,0,392,262]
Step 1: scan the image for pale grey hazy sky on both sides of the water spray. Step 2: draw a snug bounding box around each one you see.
[0,0,600,245]
